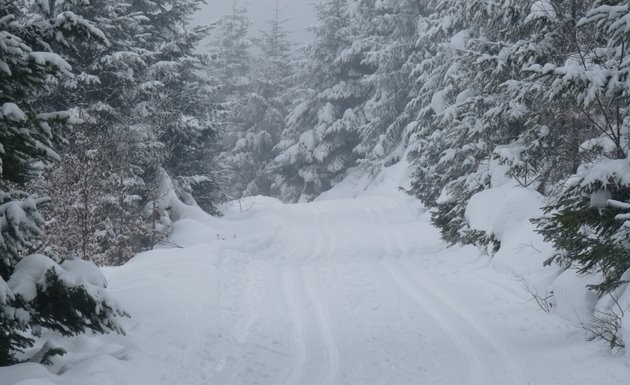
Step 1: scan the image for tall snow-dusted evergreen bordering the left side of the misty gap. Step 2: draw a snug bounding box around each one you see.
[141,0,226,214]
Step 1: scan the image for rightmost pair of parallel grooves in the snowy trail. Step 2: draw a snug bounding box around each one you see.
[357,196,528,385]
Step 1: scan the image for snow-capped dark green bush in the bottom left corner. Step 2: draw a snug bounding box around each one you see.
[0,192,125,365]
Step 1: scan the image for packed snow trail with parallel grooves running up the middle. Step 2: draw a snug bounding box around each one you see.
[198,196,528,385]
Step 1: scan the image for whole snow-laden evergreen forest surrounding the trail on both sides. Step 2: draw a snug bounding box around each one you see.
[0,0,630,372]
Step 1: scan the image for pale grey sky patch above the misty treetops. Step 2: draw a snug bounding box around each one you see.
[194,0,319,49]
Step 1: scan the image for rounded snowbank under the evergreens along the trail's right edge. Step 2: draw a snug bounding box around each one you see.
[466,162,630,352]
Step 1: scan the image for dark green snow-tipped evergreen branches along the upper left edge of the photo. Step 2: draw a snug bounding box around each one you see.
[0,0,69,184]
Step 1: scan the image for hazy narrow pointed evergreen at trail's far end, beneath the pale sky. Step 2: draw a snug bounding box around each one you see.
[223,4,293,197]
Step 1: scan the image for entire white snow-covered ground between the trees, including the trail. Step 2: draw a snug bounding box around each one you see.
[0,163,630,385]
